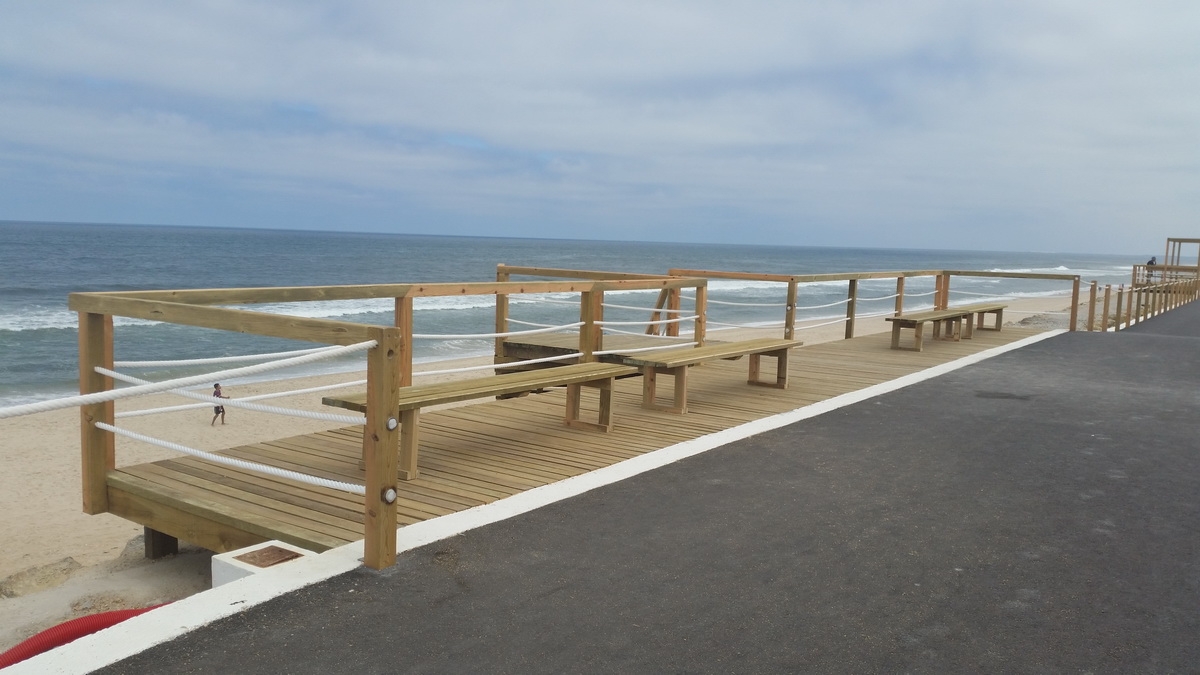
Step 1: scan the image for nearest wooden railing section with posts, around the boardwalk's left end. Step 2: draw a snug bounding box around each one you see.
[68,275,706,569]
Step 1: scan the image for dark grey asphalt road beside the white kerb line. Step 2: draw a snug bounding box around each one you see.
[101,304,1200,674]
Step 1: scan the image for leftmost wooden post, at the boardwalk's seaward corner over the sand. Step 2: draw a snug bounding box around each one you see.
[79,312,116,514]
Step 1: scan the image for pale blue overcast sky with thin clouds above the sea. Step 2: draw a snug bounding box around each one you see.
[0,0,1200,255]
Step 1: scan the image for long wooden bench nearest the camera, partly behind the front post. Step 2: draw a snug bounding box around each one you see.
[322,363,637,480]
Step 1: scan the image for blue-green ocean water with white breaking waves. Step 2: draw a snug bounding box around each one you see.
[0,221,1137,406]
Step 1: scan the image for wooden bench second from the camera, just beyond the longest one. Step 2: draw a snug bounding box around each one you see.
[620,338,804,414]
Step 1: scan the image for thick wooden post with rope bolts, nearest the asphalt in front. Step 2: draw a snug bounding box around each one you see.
[362,328,403,569]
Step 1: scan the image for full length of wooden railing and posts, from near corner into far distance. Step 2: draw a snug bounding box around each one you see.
[68,265,1200,568]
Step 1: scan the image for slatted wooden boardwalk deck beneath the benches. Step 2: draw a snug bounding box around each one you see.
[107,325,1038,551]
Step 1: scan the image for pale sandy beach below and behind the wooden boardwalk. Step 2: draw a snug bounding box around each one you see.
[0,298,1086,650]
